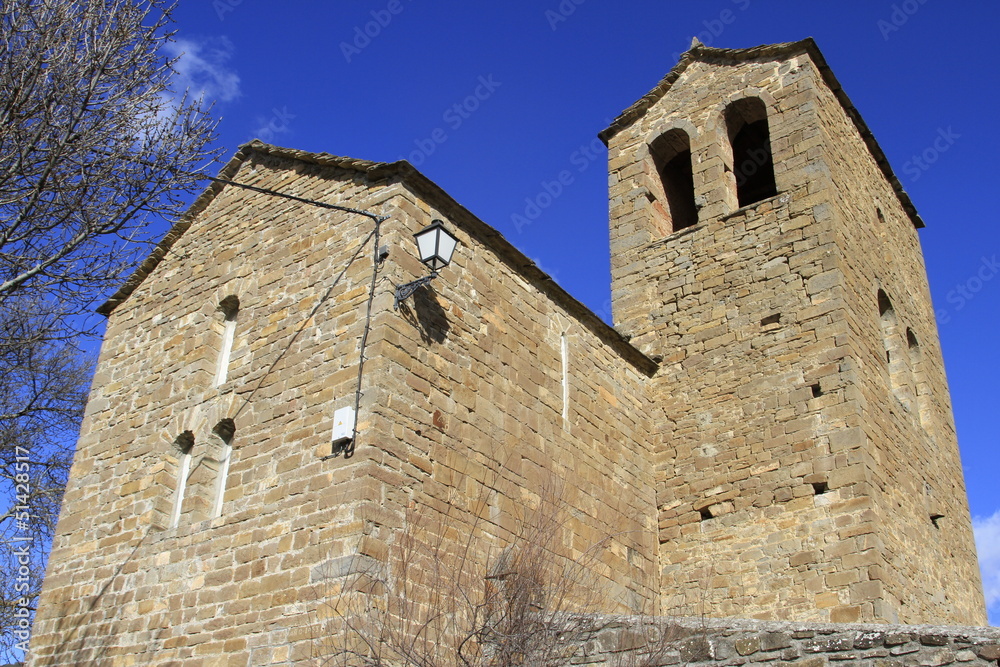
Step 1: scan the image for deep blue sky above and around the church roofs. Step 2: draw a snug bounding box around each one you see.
[166,0,1000,624]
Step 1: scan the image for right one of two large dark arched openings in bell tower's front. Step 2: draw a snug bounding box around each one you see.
[726,97,778,206]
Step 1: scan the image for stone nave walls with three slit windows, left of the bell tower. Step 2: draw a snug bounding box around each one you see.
[29,151,658,667]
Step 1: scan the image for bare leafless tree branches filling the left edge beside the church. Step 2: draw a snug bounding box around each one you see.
[0,0,218,659]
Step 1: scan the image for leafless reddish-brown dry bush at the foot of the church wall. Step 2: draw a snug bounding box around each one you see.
[313,460,692,667]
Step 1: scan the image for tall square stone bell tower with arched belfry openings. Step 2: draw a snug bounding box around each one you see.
[601,40,986,625]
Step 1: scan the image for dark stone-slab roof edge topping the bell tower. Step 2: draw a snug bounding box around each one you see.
[597,37,926,229]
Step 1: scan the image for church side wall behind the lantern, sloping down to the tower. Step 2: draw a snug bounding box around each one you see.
[334,174,659,612]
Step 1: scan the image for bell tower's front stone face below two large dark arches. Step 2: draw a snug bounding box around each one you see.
[609,54,883,622]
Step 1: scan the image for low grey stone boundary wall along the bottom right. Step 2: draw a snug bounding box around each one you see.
[567,615,1000,667]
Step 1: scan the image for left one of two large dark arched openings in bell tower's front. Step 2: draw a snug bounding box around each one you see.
[649,128,698,232]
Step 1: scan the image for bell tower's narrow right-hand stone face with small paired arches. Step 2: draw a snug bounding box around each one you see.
[804,57,986,623]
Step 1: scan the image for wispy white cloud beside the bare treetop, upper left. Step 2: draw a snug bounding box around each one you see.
[163,37,240,103]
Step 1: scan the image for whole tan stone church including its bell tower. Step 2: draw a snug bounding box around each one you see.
[28,40,986,666]
